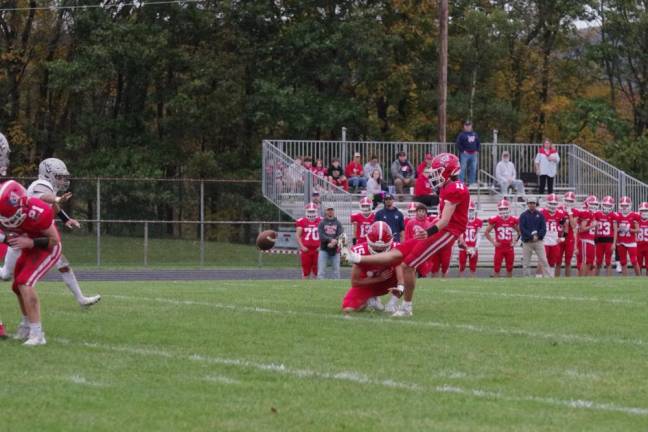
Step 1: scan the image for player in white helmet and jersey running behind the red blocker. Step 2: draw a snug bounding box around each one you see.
[0,158,101,307]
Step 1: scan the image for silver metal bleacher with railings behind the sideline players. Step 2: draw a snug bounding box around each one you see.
[262,140,648,266]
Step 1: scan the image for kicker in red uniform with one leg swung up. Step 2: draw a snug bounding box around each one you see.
[342,153,470,317]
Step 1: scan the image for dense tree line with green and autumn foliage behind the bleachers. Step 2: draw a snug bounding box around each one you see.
[0,0,648,180]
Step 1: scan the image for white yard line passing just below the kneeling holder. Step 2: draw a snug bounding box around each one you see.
[104,294,648,347]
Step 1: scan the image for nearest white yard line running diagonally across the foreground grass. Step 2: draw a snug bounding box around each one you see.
[55,338,648,416]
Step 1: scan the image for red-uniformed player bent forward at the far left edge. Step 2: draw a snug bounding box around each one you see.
[0,180,61,346]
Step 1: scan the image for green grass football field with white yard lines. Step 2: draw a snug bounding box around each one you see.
[0,278,648,432]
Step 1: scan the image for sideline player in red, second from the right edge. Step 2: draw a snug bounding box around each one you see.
[614,196,641,276]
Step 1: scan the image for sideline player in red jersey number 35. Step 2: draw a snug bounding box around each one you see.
[484,199,520,277]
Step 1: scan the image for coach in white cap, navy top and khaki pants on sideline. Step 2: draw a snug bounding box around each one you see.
[520,197,554,277]
